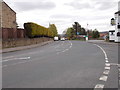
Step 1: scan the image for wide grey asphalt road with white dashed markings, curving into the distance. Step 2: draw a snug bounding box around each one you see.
[2,41,118,90]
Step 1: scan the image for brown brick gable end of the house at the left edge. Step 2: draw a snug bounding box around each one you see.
[0,1,17,29]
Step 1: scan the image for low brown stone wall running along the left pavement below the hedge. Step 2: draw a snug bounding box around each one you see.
[2,37,53,48]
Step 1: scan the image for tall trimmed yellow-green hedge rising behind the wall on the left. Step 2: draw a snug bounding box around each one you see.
[24,22,57,38]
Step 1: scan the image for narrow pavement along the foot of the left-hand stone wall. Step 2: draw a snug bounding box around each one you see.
[0,41,53,53]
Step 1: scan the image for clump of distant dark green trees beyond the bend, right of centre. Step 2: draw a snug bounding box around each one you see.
[66,23,100,40]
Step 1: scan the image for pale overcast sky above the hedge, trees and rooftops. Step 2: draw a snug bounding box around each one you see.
[4,0,119,34]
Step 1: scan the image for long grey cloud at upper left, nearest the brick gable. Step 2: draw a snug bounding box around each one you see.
[14,1,56,11]
